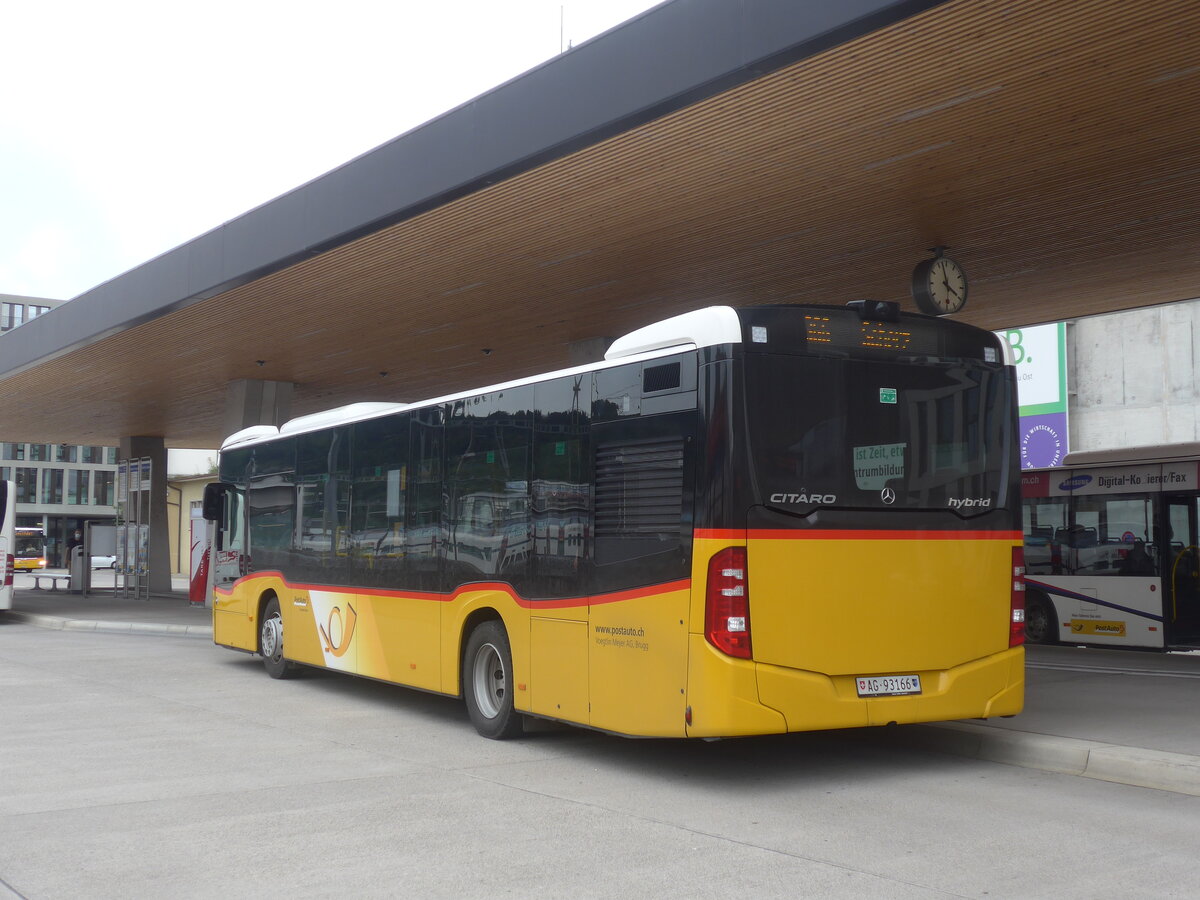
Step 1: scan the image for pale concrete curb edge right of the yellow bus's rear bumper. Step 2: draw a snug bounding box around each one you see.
[900,722,1200,797]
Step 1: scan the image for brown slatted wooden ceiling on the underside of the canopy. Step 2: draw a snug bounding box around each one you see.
[0,0,1200,448]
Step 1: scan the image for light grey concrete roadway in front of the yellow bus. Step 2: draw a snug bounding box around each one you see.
[0,619,1200,900]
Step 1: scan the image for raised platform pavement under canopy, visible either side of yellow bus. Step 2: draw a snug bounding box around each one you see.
[10,574,1200,796]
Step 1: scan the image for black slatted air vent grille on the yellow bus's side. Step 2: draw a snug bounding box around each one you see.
[595,438,683,538]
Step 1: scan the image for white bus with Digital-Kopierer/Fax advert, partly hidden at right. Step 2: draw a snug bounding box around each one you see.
[1021,444,1200,649]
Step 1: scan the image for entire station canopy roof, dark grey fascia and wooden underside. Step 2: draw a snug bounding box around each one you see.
[0,0,1200,448]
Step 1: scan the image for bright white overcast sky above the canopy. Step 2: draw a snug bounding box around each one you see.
[0,0,656,300]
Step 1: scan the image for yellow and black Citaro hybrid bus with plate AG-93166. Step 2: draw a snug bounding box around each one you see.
[204,301,1025,738]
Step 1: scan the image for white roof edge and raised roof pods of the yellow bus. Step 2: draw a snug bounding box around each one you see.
[221,306,742,450]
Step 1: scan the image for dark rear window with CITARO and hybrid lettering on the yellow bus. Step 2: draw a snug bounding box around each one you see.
[745,354,1012,516]
